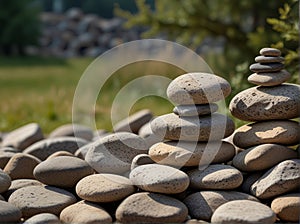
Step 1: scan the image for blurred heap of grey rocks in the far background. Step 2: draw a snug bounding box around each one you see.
[35,8,142,57]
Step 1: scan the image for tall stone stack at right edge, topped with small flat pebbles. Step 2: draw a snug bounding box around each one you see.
[229,48,300,222]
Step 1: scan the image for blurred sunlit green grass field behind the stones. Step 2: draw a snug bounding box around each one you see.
[0,58,183,133]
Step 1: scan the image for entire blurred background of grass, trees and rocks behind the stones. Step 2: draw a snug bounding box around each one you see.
[0,0,299,133]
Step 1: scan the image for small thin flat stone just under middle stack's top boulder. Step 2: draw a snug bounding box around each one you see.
[173,103,218,117]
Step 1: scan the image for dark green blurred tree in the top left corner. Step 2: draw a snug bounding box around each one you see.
[0,0,40,55]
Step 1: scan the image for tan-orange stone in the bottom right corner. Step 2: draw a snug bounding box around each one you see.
[271,193,300,223]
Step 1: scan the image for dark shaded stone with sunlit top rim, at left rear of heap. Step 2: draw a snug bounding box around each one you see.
[24,137,88,160]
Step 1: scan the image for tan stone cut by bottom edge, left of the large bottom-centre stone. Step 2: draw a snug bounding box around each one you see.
[60,201,112,224]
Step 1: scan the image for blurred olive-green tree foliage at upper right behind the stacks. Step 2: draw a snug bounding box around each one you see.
[115,0,298,95]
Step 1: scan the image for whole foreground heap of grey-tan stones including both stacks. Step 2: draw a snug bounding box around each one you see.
[0,62,300,224]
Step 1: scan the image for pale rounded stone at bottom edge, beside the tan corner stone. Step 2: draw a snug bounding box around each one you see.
[211,200,276,224]
